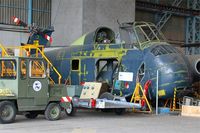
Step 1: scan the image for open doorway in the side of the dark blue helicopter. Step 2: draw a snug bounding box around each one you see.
[96,59,118,86]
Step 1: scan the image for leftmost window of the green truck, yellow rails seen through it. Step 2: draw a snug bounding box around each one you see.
[0,60,17,79]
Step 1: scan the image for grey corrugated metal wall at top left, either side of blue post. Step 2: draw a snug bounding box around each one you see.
[0,0,51,27]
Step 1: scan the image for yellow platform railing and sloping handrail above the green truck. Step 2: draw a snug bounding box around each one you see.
[0,41,62,84]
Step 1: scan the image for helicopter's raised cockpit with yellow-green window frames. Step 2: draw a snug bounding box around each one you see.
[120,22,166,49]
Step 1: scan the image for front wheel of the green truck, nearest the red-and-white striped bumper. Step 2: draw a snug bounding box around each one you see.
[44,103,61,121]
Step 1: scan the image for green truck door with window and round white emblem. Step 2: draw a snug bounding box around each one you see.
[28,59,49,105]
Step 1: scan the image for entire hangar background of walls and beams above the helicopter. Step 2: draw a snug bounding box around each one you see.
[0,0,200,48]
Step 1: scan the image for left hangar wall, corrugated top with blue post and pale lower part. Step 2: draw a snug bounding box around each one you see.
[0,0,51,46]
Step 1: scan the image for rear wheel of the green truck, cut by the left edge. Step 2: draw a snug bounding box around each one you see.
[0,101,17,124]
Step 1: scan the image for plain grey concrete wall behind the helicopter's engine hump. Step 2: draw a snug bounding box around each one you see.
[52,0,135,46]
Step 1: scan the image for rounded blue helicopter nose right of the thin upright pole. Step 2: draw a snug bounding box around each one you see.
[151,55,190,99]
